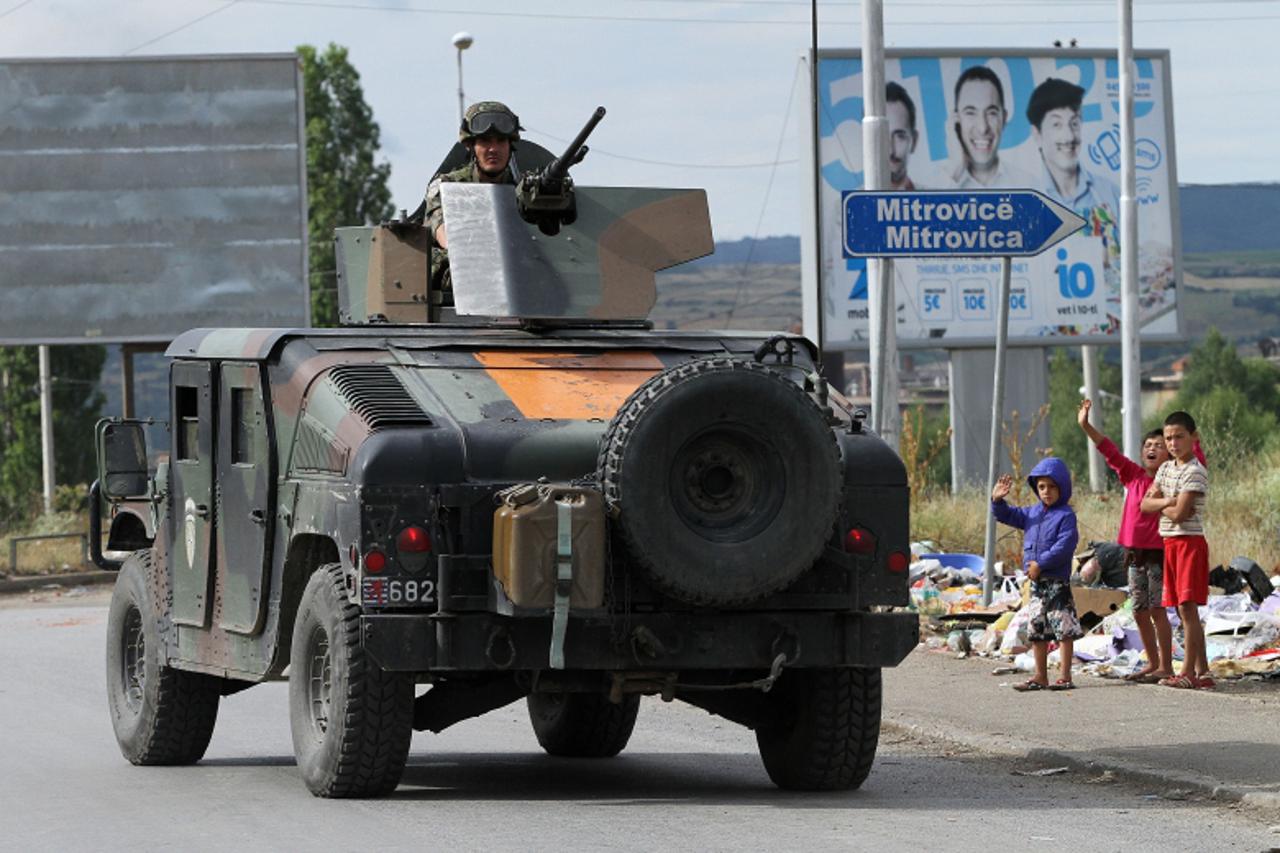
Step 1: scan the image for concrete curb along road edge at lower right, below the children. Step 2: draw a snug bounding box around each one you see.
[881,717,1280,818]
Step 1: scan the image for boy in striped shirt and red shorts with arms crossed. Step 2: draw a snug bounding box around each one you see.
[1142,411,1215,689]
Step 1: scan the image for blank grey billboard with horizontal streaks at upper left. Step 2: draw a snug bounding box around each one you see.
[0,54,308,345]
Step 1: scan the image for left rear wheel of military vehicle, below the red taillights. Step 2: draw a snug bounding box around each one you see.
[289,565,413,798]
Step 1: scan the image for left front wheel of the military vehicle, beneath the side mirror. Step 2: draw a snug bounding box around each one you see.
[106,551,221,765]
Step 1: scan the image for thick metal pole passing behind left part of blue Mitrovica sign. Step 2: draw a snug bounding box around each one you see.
[863,0,899,450]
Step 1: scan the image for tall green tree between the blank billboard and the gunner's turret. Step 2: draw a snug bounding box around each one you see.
[298,44,394,327]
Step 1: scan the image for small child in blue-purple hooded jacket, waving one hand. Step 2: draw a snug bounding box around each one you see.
[991,456,1084,692]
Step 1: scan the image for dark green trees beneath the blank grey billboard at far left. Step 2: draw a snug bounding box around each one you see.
[0,346,106,526]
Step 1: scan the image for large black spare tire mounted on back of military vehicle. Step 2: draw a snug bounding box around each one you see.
[598,357,844,605]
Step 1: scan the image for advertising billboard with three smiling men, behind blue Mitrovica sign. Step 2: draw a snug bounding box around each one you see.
[817,49,1181,350]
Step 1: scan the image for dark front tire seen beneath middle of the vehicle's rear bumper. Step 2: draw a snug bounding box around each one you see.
[527,693,640,758]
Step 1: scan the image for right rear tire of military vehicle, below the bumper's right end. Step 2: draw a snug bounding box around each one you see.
[755,670,881,790]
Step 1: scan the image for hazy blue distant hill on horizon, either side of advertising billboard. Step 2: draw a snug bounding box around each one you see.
[689,183,1280,263]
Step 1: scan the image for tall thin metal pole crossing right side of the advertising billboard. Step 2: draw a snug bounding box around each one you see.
[1119,0,1142,459]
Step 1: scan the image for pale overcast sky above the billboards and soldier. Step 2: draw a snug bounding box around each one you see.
[0,0,1280,240]
